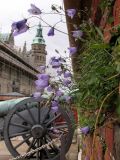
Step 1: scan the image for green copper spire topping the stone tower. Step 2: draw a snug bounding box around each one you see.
[32,23,45,44]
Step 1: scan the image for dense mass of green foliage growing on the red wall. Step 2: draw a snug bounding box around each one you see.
[73,24,120,128]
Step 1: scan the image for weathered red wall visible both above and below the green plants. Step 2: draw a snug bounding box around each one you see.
[83,0,120,160]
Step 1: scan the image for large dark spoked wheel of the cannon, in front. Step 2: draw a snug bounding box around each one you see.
[4,98,74,160]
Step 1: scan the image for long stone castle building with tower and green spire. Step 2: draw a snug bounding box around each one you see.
[0,24,46,95]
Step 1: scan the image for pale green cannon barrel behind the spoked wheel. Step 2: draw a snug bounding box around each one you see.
[0,97,28,117]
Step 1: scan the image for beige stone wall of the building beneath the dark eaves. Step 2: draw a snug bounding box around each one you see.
[0,62,35,95]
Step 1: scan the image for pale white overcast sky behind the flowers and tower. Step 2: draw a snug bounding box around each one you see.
[0,0,69,61]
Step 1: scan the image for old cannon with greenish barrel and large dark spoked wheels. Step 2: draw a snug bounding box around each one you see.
[0,97,74,160]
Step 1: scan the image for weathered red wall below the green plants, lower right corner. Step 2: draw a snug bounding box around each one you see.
[82,124,114,160]
